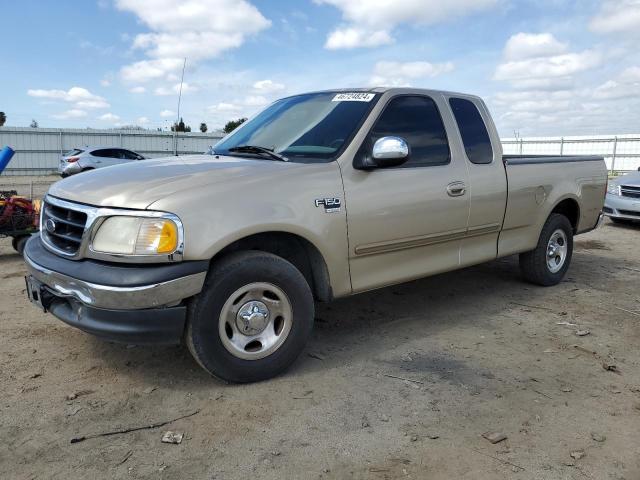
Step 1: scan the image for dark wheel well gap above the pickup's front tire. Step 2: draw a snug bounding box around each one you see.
[211,230,333,302]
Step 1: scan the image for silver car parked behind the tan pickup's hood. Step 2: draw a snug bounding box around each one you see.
[58,147,145,177]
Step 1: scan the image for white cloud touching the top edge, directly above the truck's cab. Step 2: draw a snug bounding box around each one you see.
[314,0,499,50]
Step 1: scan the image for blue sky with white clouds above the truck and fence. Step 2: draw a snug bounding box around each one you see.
[0,0,640,136]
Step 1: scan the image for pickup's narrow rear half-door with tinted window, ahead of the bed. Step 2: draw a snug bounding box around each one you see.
[448,96,507,266]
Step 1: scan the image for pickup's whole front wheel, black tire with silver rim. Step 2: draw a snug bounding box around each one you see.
[185,251,314,383]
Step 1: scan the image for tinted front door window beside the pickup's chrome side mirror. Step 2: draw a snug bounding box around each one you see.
[371,95,450,167]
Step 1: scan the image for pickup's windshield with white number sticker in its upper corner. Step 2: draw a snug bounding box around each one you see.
[212,92,377,162]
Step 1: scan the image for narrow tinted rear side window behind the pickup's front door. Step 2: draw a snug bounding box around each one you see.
[449,98,493,164]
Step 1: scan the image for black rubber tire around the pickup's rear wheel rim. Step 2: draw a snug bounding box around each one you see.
[520,213,573,287]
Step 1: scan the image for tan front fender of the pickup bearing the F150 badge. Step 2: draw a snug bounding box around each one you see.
[148,163,351,297]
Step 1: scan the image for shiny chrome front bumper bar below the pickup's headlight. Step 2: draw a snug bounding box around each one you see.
[24,246,206,310]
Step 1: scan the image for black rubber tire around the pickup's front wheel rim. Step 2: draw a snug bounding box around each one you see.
[185,251,314,383]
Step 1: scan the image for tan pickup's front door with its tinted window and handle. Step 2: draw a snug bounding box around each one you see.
[343,94,469,292]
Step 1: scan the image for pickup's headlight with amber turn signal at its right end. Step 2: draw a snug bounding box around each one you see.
[91,216,180,255]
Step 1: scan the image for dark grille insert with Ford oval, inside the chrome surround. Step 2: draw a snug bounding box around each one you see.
[41,203,87,255]
